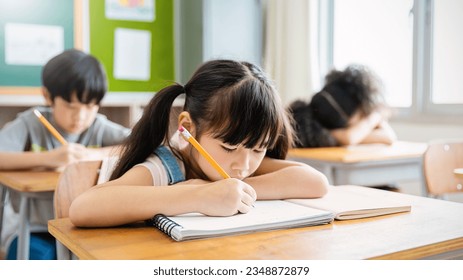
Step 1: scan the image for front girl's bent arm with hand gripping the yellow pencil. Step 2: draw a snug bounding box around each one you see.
[69,166,256,227]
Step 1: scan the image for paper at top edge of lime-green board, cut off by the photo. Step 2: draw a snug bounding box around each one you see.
[105,0,155,22]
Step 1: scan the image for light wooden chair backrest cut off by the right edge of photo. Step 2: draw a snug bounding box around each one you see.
[423,140,463,197]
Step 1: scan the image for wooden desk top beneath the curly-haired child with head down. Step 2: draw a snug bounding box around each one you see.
[288,141,427,163]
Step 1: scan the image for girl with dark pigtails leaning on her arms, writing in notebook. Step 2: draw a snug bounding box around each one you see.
[69,60,328,227]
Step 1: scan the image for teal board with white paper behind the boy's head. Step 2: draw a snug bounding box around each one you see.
[0,0,77,94]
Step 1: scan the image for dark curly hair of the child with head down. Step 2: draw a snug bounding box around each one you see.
[310,64,383,129]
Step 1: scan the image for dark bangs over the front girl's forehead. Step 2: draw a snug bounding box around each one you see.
[203,79,284,149]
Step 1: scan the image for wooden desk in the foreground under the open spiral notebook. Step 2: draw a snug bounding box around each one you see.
[48,188,463,260]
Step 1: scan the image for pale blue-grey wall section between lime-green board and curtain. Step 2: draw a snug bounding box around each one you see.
[176,0,263,83]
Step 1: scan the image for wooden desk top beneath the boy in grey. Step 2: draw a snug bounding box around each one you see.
[0,171,61,192]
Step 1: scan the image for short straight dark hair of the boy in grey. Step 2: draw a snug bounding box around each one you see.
[42,49,108,104]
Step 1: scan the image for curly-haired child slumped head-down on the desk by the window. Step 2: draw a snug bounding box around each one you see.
[289,65,397,148]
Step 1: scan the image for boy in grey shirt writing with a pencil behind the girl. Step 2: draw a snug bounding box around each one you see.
[0,49,130,259]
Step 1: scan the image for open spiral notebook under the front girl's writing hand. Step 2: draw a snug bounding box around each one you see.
[147,186,411,241]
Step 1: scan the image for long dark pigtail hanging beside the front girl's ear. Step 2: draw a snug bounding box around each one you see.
[110,84,185,180]
